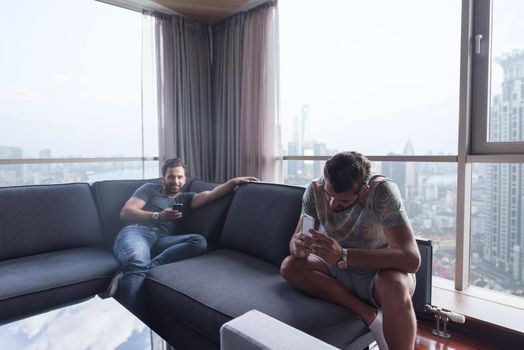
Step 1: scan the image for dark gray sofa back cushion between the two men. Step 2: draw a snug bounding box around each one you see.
[220,182,304,266]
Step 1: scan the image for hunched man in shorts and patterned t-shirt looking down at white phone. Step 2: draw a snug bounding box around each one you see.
[280,152,420,350]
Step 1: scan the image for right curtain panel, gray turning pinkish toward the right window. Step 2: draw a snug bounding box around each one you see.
[213,2,281,181]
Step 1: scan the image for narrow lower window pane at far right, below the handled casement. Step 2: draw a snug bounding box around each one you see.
[469,163,524,296]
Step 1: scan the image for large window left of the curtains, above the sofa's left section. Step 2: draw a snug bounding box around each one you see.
[0,0,158,186]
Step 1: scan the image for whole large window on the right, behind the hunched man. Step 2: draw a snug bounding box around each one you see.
[279,0,524,304]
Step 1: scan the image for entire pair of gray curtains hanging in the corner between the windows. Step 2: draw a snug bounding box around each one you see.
[144,1,281,181]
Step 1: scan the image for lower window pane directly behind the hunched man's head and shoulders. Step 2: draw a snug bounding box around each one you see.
[284,160,457,280]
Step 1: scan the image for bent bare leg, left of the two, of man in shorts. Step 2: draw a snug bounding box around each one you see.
[280,255,377,326]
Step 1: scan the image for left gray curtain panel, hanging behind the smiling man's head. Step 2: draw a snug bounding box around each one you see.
[154,14,214,179]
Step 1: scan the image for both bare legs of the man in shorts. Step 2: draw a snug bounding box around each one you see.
[280,255,416,350]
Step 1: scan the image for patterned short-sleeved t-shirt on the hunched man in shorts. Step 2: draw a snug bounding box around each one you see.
[302,177,409,249]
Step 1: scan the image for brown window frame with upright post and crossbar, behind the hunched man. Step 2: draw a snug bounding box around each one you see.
[281,0,524,307]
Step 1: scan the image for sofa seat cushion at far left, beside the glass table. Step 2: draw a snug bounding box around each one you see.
[0,248,118,324]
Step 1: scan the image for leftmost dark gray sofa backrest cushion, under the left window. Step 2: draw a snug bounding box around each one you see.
[0,183,102,260]
